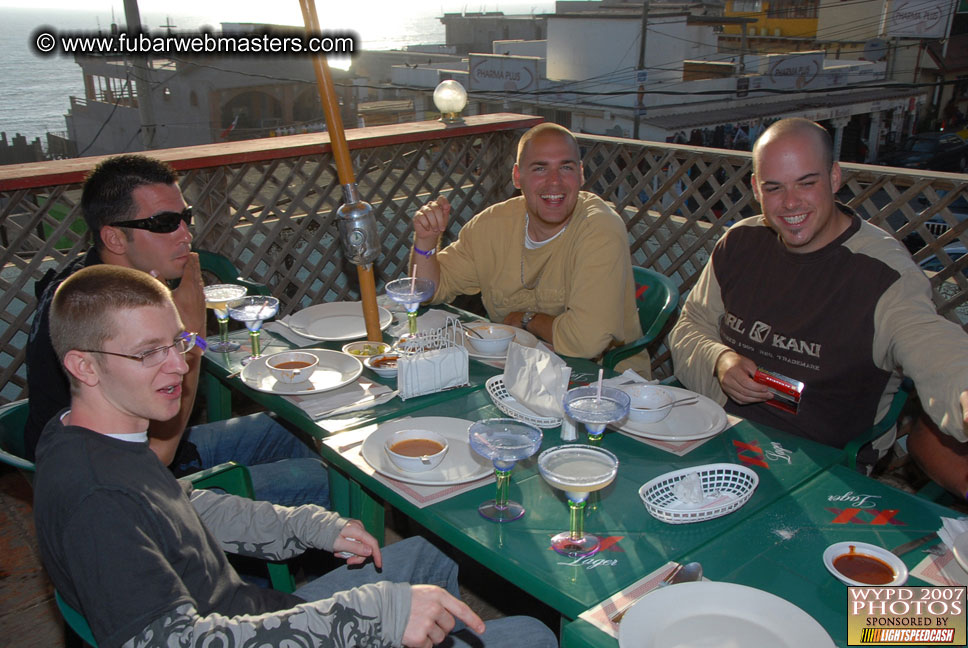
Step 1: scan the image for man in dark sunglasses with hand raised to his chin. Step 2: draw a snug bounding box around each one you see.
[25,155,329,506]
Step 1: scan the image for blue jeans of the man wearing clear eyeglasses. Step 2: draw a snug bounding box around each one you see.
[294,537,558,648]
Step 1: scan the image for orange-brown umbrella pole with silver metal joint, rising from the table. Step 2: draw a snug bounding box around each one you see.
[299,0,383,342]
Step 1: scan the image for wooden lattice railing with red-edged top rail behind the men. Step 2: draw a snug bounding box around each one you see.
[0,114,968,402]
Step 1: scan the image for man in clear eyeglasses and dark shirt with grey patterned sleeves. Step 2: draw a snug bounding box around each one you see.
[34,264,557,648]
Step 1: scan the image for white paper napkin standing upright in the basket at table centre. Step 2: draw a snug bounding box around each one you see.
[504,342,571,418]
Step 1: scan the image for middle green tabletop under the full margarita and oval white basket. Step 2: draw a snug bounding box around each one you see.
[322,382,841,619]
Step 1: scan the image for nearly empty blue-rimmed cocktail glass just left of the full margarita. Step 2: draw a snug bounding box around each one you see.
[469,418,543,522]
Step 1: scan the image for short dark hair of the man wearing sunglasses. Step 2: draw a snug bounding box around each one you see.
[81,155,178,248]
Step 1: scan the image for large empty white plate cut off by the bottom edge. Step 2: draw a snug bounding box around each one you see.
[618,581,834,648]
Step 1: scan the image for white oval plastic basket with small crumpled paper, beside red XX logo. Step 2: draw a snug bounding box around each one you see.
[639,463,760,524]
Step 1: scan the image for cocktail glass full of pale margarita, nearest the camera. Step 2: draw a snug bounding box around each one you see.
[538,444,618,557]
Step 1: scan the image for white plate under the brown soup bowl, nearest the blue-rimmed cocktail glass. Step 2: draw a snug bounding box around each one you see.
[360,416,494,486]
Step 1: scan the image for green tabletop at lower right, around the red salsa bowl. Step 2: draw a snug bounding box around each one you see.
[562,465,957,648]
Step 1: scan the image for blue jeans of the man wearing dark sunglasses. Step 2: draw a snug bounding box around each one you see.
[185,414,329,508]
